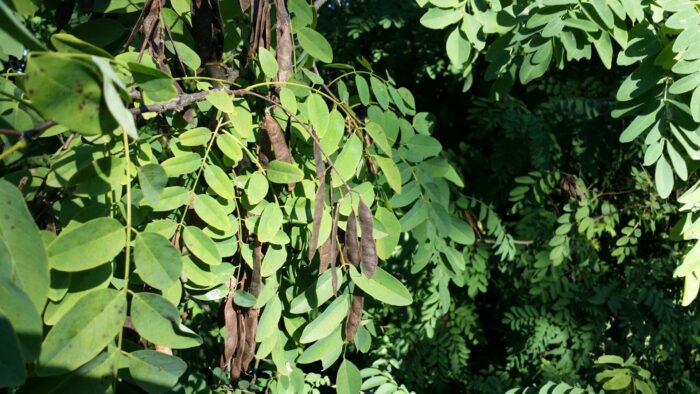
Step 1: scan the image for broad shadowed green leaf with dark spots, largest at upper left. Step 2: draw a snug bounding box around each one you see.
[24,53,117,135]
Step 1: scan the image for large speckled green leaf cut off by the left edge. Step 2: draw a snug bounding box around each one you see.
[0,179,49,313]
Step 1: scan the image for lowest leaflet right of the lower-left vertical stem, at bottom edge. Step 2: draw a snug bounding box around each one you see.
[128,350,187,394]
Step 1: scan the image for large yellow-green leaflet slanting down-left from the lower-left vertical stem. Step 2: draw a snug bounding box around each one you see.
[37,289,127,376]
